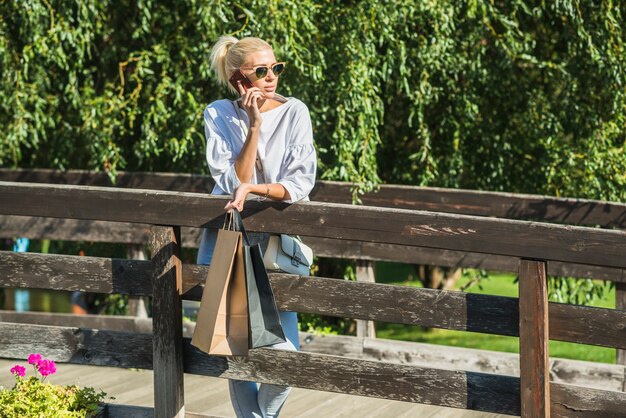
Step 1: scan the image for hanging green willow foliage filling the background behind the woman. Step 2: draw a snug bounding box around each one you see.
[0,0,626,201]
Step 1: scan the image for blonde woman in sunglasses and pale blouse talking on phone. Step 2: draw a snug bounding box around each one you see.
[198,36,317,418]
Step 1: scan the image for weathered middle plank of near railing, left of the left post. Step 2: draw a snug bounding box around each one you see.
[0,251,152,296]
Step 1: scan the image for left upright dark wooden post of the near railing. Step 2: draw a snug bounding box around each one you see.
[150,226,185,418]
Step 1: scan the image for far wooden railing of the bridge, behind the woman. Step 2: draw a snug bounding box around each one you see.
[0,169,626,342]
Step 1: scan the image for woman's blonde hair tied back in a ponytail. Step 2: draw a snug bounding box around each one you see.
[211,36,272,93]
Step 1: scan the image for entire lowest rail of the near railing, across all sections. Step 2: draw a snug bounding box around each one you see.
[0,323,626,417]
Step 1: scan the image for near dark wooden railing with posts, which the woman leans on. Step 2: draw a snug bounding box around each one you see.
[0,178,626,417]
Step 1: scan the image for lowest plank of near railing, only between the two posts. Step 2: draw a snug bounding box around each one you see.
[185,341,519,415]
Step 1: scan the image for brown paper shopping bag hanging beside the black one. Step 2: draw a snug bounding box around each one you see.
[191,229,249,356]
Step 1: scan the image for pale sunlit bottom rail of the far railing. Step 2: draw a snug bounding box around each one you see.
[0,311,626,391]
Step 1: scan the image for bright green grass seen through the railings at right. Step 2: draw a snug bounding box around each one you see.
[376,263,615,364]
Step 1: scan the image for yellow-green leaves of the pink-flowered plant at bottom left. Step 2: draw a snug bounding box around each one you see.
[0,376,106,418]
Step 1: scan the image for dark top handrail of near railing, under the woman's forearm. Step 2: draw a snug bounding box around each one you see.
[0,182,626,269]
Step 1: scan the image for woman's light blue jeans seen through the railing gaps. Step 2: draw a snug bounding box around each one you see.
[197,229,300,418]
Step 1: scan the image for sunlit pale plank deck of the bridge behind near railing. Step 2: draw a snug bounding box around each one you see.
[0,360,509,418]
